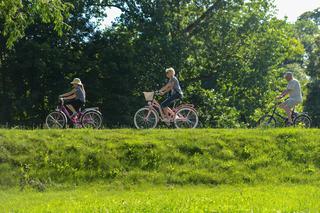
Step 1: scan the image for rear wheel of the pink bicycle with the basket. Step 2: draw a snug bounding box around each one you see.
[174,108,199,129]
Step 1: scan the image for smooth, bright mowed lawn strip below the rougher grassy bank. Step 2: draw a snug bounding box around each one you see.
[0,184,320,212]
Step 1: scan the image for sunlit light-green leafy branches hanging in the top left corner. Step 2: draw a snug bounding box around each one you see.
[0,0,72,48]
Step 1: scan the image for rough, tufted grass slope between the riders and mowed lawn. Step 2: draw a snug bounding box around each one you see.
[0,129,320,191]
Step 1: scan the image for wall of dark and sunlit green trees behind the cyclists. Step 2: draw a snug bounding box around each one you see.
[0,0,319,127]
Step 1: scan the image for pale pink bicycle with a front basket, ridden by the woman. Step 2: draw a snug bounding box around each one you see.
[134,91,199,129]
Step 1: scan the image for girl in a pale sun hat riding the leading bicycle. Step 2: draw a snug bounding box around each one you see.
[59,78,86,117]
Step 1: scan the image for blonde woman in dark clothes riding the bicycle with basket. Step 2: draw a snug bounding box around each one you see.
[159,67,183,121]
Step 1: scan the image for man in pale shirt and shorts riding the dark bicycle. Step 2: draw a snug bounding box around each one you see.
[277,72,302,126]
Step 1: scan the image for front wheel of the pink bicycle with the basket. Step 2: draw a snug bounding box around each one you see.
[134,107,159,129]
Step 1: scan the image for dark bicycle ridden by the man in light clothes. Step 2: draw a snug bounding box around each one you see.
[258,103,312,128]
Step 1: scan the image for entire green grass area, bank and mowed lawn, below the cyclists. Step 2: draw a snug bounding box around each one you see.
[0,129,320,212]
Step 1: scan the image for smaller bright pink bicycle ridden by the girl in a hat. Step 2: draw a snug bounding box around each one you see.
[46,99,102,129]
